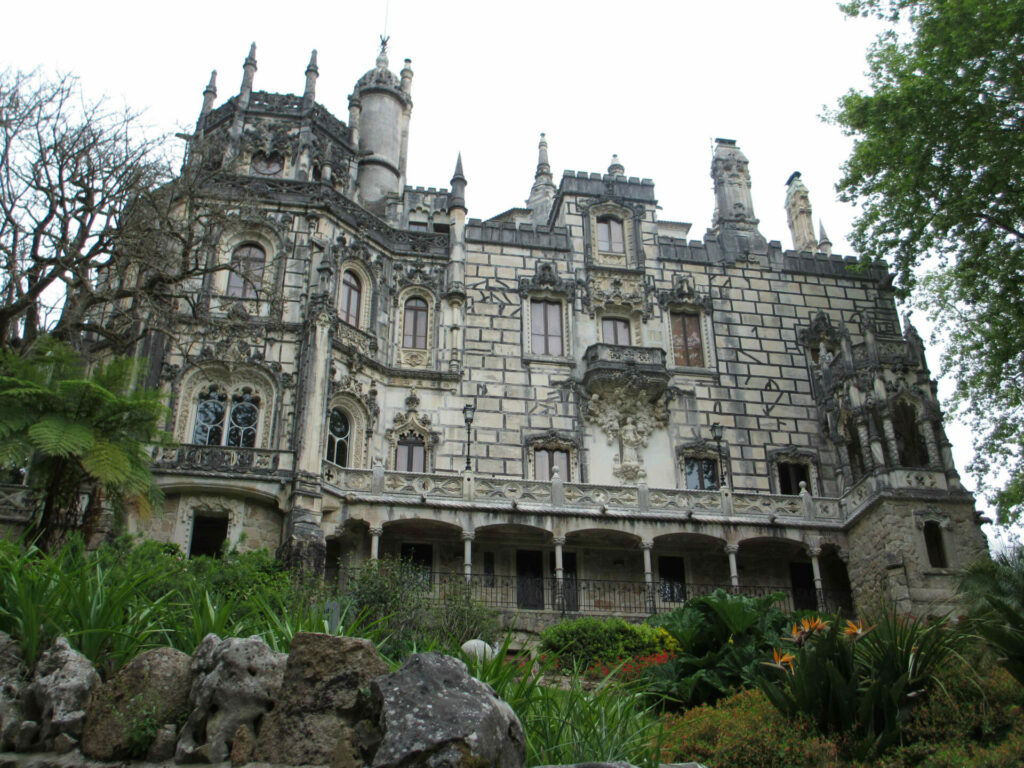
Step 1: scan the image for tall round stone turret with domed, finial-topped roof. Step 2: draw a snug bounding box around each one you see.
[349,38,413,213]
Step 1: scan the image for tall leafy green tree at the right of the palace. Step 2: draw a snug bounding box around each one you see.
[835,0,1024,522]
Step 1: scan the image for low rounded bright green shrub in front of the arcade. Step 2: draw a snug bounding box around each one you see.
[541,616,665,671]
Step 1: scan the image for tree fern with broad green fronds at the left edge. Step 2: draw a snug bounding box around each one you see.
[0,337,167,549]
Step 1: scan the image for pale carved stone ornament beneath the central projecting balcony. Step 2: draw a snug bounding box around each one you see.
[583,387,669,482]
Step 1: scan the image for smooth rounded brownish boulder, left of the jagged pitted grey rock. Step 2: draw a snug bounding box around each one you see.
[82,648,191,760]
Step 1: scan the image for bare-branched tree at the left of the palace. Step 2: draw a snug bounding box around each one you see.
[0,70,230,353]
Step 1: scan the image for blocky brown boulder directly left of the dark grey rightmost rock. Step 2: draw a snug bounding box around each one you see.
[255,633,388,765]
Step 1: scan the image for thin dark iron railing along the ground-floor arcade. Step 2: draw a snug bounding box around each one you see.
[380,570,852,615]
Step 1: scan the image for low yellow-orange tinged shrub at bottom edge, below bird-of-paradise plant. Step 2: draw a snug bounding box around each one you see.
[662,690,839,768]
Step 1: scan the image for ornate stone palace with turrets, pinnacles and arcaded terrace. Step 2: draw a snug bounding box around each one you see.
[123,40,986,615]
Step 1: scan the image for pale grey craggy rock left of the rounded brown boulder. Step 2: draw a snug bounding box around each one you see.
[22,637,99,750]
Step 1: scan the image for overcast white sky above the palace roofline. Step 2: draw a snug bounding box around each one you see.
[0,0,999,540]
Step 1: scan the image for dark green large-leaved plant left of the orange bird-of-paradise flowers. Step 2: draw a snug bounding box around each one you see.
[646,590,788,707]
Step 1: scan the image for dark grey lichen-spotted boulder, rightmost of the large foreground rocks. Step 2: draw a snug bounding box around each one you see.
[371,653,526,768]
